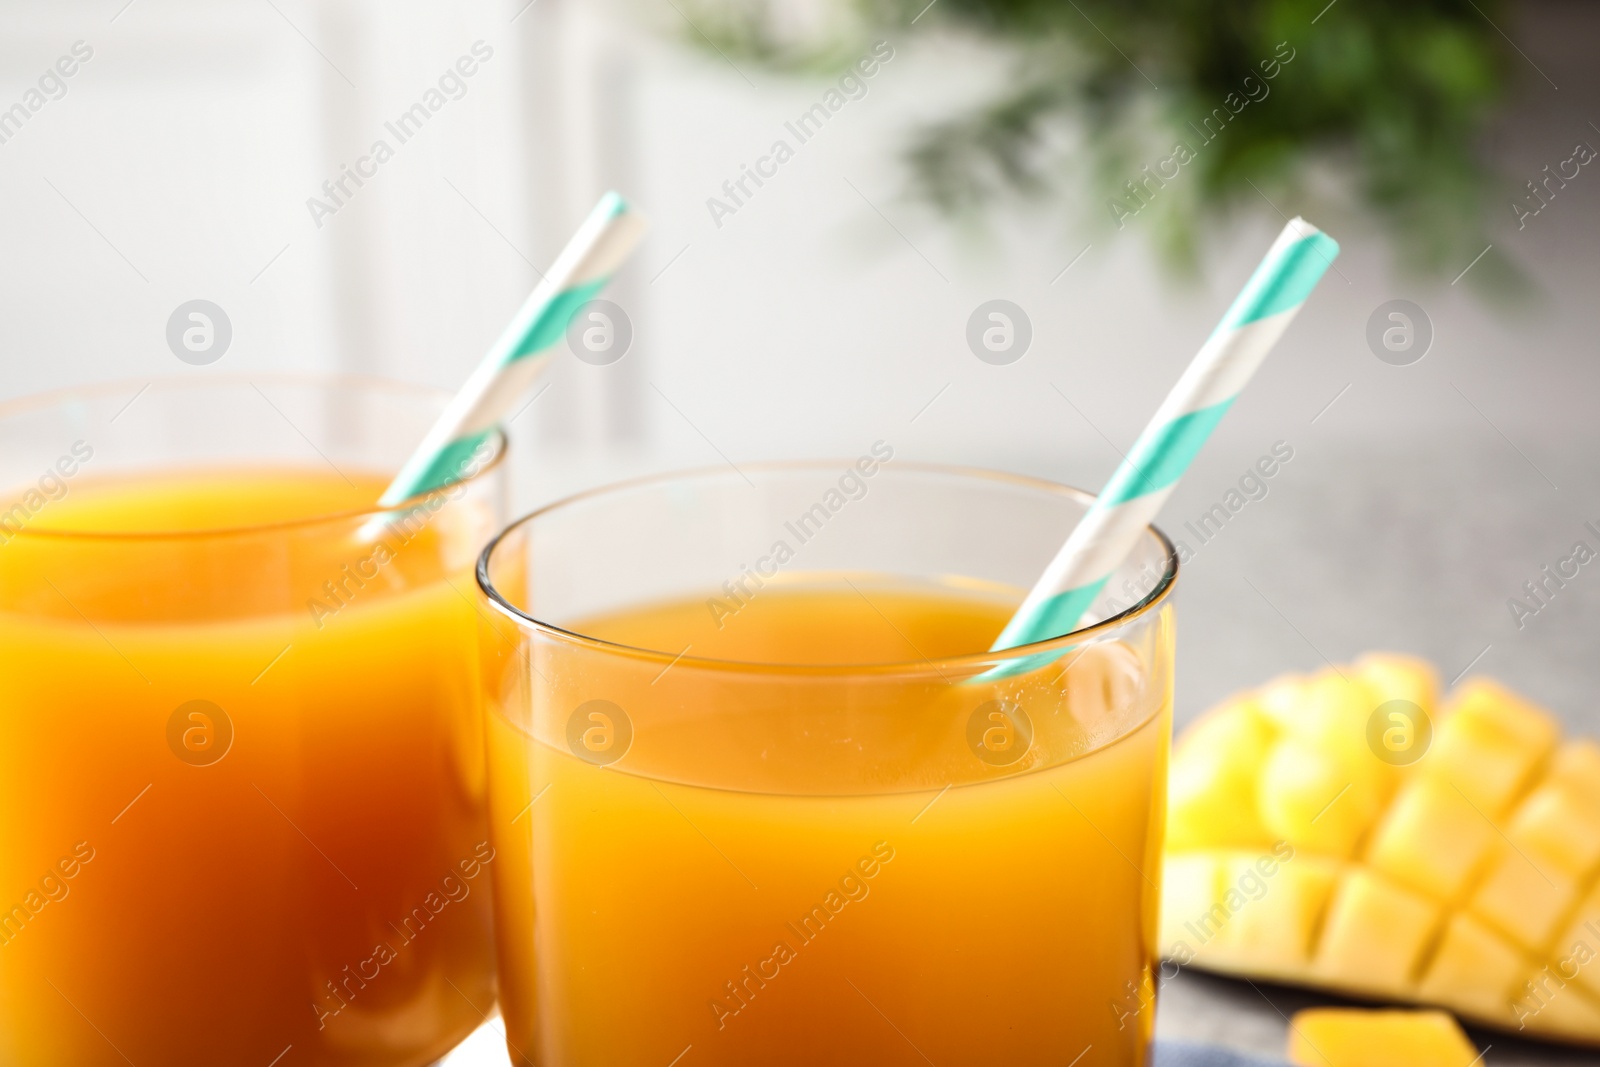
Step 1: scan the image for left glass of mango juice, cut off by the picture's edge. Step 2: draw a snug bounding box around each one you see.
[0,378,502,1067]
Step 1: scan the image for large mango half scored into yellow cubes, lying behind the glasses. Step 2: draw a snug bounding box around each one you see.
[1160,654,1600,1043]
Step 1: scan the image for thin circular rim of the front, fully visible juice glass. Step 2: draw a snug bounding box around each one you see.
[474,459,1179,675]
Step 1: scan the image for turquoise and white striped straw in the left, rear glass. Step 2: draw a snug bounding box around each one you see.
[378,192,645,507]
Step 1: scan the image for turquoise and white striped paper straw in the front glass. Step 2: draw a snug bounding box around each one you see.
[990,219,1339,651]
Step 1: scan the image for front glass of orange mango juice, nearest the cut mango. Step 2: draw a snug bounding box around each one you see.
[478,460,1178,1067]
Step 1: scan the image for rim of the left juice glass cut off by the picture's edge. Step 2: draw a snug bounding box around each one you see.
[0,371,509,542]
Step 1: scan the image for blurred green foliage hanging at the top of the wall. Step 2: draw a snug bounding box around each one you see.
[688,0,1514,277]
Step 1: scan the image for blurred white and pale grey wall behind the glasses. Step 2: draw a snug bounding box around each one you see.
[0,0,1600,725]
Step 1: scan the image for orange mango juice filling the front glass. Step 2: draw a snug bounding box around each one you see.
[486,576,1170,1067]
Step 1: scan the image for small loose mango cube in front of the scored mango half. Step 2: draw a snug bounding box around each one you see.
[1288,1008,1478,1067]
